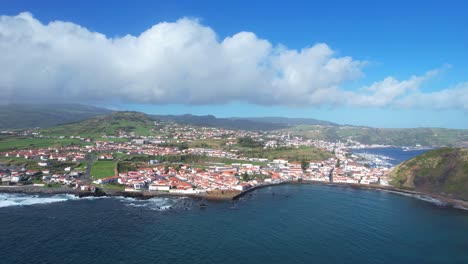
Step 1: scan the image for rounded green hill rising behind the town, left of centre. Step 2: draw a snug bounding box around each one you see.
[41,112,155,137]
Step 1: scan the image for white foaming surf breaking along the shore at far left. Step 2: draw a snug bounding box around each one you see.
[0,194,79,208]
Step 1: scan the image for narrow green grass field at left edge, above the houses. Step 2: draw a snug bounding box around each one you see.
[0,137,80,152]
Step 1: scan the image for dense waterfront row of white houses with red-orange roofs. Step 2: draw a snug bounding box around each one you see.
[94,154,390,194]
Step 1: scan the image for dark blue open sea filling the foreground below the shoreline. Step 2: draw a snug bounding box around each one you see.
[0,185,468,264]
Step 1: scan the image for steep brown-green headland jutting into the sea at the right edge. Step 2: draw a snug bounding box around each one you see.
[390,148,468,201]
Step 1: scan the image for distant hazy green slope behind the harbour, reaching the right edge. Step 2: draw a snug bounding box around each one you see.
[292,125,468,146]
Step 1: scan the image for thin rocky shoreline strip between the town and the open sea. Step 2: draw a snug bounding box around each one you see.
[0,180,468,211]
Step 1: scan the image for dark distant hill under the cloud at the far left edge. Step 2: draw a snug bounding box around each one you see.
[0,104,112,129]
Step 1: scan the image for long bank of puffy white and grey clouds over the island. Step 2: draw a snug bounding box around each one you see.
[0,13,468,109]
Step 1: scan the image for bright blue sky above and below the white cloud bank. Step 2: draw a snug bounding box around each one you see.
[0,0,468,128]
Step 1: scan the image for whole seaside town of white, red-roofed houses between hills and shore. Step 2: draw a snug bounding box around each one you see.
[0,123,391,196]
